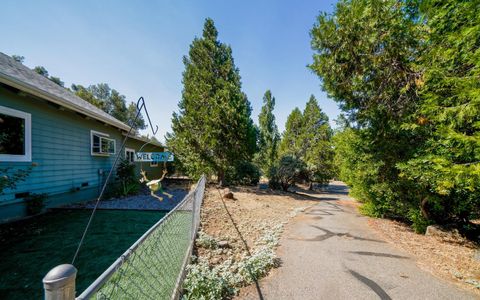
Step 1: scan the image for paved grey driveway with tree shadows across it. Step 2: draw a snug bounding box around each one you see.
[240,182,477,300]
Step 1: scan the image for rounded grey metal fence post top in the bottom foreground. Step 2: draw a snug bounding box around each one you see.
[43,264,77,300]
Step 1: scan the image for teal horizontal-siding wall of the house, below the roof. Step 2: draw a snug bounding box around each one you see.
[0,86,163,222]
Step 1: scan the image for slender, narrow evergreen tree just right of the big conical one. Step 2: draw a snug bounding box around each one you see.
[255,90,280,174]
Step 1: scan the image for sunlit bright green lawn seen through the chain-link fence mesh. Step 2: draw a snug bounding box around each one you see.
[93,211,192,300]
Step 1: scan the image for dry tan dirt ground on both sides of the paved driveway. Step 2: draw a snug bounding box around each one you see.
[197,186,480,295]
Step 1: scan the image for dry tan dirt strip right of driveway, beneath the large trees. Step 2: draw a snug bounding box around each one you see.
[368,219,480,296]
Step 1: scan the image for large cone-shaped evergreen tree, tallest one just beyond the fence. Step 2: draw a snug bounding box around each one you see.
[166,19,256,184]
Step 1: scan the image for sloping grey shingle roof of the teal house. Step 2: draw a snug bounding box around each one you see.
[0,52,162,146]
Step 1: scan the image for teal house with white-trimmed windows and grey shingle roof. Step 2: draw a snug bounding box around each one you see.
[0,52,163,222]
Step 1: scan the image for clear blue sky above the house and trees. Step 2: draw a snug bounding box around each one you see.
[0,0,339,140]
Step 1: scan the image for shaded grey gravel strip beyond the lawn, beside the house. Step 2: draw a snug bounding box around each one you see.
[67,188,188,210]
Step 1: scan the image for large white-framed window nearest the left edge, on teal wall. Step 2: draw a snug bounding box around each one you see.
[0,106,32,161]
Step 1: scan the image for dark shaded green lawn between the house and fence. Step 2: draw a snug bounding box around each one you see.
[0,210,167,299]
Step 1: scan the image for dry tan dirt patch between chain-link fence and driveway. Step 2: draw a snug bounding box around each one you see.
[197,186,315,265]
